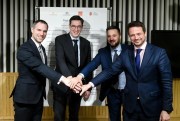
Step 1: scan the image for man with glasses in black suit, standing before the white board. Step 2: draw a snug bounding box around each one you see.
[52,15,91,121]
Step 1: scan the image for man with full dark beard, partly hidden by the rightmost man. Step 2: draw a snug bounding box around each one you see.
[70,26,126,121]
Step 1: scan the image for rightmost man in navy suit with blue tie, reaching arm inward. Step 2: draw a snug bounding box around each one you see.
[81,21,173,121]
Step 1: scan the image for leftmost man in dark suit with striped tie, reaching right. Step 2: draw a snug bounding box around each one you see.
[11,20,69,121]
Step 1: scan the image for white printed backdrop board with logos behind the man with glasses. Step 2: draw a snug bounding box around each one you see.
[40,7,107,106]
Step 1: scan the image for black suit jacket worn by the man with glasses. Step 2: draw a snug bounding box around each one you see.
[53,33,92,92]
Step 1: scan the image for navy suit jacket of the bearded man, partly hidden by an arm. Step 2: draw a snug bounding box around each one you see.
[81,45,126,101]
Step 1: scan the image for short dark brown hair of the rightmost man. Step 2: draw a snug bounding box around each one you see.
[127,21,146,33]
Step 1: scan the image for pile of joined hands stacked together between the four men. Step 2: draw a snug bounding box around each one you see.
[62,74,92,99]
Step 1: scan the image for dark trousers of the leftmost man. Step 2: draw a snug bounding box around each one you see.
[14,98,43,121]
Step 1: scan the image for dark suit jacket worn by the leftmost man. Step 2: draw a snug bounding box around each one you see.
[11,39,65,104]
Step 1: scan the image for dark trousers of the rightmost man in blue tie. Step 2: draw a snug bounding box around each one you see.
[123,100,159,121]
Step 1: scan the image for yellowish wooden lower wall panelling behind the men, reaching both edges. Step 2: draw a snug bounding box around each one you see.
[0,73,180,121]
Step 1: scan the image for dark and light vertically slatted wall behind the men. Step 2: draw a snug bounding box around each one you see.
[0,0,180,72]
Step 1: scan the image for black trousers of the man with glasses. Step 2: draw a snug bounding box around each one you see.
[53,91,81,121]
